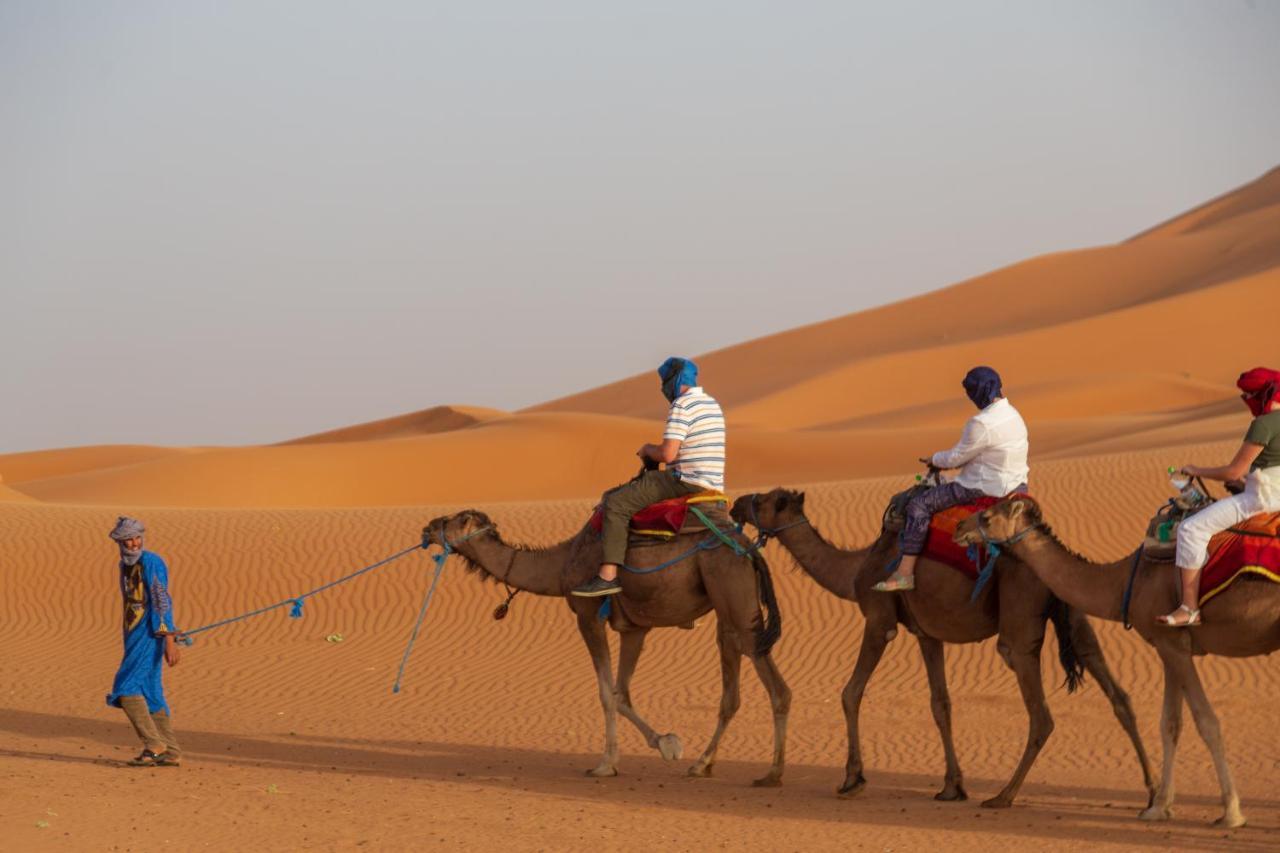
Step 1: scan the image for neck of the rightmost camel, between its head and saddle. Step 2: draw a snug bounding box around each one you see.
[1009,529,1133,622]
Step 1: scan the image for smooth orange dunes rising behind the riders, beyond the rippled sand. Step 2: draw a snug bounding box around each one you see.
[0,169,1280,507]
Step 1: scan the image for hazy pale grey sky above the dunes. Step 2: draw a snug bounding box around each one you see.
[0,0,1280,452]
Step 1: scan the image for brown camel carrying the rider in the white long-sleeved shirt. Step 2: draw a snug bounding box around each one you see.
[732,489,1153,808]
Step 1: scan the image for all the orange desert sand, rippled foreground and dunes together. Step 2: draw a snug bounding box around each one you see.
[0,170,1280,850]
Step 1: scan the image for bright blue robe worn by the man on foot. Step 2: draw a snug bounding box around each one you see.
[106,551,178,713]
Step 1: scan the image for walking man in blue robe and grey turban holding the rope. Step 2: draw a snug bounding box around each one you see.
[106,516,182,767]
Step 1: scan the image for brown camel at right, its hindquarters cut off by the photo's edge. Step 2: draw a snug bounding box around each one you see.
[956,498,1280,826]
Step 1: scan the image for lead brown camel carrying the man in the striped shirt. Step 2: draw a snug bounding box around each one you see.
[422,510,791,786]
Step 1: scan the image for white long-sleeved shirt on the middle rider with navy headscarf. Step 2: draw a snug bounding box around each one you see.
[933,397,1028,497]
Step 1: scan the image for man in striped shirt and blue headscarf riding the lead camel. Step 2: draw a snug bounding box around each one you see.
[572,356,724,597]
